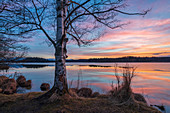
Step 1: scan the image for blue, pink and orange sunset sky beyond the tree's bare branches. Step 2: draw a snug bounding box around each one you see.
[25,0,170,59]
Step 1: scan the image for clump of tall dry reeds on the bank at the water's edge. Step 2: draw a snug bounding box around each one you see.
[110,65,136,103]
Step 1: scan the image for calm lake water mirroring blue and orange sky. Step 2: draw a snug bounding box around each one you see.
[0,63,170,112]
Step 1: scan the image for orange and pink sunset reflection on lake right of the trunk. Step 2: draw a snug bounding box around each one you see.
[67,63,170,105]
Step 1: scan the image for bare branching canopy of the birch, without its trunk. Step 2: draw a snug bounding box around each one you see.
[0,0,149,45]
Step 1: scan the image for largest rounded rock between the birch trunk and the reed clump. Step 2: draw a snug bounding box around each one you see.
[77,88,92,97]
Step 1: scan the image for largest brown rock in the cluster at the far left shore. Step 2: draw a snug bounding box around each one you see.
[2,79,17,94]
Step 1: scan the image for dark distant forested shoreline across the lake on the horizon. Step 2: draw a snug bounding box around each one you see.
[0,56,170,63]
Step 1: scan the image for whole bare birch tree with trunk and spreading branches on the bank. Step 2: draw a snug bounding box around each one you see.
[0,0,149,98]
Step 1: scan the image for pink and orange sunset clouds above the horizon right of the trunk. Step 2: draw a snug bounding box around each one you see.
[69,19,170,59]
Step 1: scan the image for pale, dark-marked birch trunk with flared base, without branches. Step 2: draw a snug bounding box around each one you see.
[38,0,68,99]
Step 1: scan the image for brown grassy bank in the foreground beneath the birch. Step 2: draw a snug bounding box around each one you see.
[0,92,160,113]
